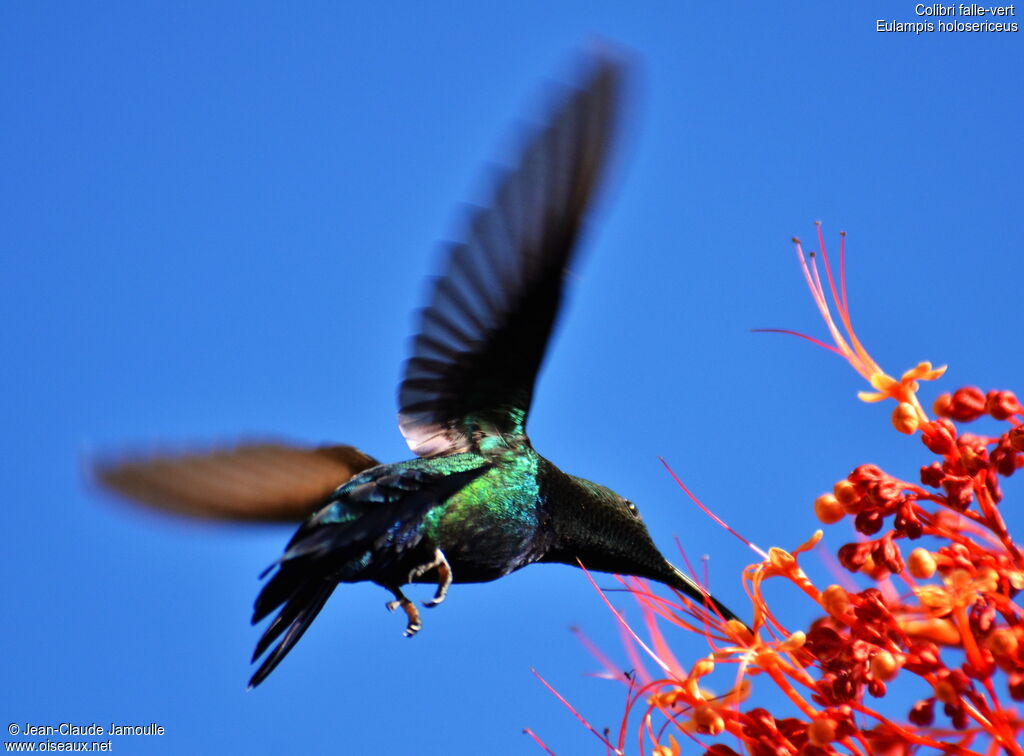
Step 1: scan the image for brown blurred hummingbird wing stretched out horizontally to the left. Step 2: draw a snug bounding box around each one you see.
[94,444,379,522]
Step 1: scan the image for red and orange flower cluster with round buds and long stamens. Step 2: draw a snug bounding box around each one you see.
[532,223,1024,756]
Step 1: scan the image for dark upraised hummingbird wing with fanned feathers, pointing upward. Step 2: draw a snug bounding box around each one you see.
[398,58,622,457]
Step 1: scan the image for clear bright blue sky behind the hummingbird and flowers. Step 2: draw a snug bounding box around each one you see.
[0,2,1024,754]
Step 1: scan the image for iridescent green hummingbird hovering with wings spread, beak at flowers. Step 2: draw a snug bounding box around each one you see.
[96,54,736,688]
